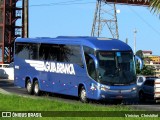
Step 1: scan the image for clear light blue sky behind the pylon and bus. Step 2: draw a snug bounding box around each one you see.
[23,0,160,56]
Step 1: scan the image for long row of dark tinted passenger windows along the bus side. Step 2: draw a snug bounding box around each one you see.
[15,43,82,65]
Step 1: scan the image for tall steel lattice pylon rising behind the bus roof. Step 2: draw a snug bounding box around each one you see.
[91,0,119,39]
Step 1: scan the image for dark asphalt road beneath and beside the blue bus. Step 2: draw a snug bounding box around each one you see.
[0,79,160,111]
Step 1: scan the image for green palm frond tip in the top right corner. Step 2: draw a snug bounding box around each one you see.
[149,0,160,14]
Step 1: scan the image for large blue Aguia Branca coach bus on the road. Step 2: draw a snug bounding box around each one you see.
[14,36,137,102]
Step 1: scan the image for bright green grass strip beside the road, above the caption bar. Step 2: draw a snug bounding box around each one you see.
[0,94,132,111]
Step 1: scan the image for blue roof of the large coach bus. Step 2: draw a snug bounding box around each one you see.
[15,36,132,51]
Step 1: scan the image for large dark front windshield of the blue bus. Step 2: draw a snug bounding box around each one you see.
[97,51,136,85]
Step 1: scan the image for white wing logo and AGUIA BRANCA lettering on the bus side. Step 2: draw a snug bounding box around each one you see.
[25,60,75,75]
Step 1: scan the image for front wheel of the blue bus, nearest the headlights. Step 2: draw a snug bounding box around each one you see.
[79,86,88,103]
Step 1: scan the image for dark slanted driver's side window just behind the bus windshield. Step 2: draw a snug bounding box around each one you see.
[85,54,96,80]
